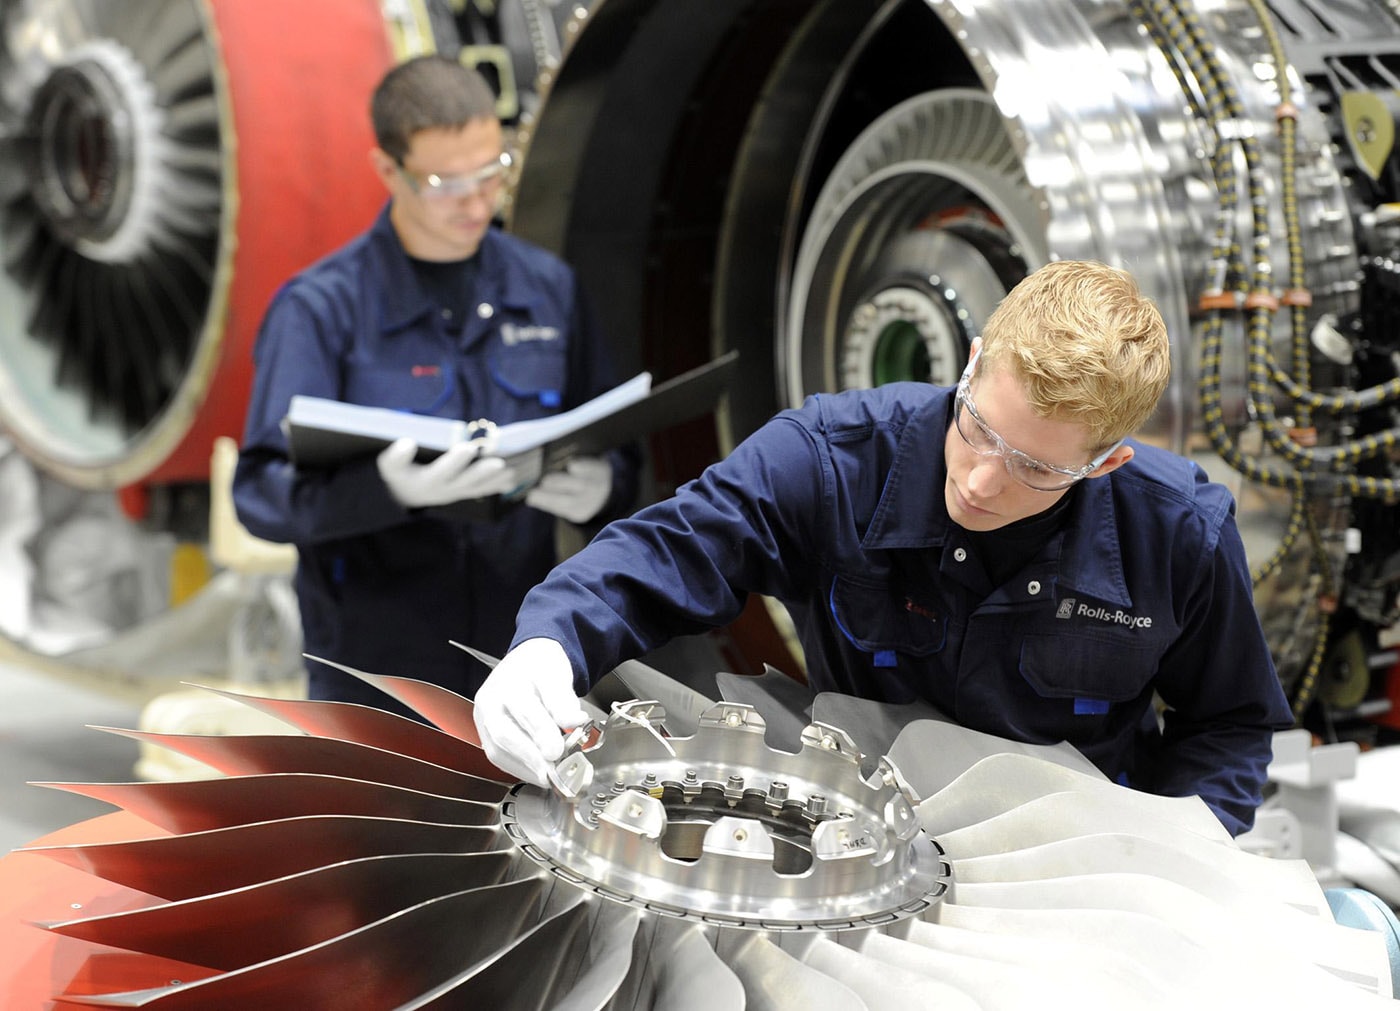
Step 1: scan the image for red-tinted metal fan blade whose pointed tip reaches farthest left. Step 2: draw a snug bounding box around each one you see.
[17,815,500,900]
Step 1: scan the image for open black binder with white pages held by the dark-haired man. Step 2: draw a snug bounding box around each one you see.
[283,351,739,473]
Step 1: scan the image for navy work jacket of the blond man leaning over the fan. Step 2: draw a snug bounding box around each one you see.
[515,384,1291,833]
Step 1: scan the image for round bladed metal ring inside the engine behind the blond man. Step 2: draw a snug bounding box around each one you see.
[778,88,1046,406]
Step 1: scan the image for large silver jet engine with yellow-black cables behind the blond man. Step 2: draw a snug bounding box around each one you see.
[512,0,1400,738]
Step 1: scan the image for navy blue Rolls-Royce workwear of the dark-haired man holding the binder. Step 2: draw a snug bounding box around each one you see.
[234,209,637,709]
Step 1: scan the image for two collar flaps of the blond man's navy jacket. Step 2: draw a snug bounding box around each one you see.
[861,386,1133,608]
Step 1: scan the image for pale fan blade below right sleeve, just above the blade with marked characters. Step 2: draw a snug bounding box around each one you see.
[918,750,1231,843]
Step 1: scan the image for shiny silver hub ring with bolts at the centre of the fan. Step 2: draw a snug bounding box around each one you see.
[501,702,951,930]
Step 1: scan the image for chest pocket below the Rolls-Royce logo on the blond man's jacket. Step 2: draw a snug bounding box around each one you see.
[1021,634,1158,700]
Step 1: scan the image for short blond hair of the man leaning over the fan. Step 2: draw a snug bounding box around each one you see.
[979,260,1172,449]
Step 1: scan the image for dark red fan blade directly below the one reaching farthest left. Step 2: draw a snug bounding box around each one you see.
[39,851,511,970]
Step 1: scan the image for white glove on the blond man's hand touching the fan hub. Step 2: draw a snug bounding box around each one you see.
[475,639,588,787]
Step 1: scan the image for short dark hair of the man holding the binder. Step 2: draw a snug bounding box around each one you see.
[370,53,496,161]
